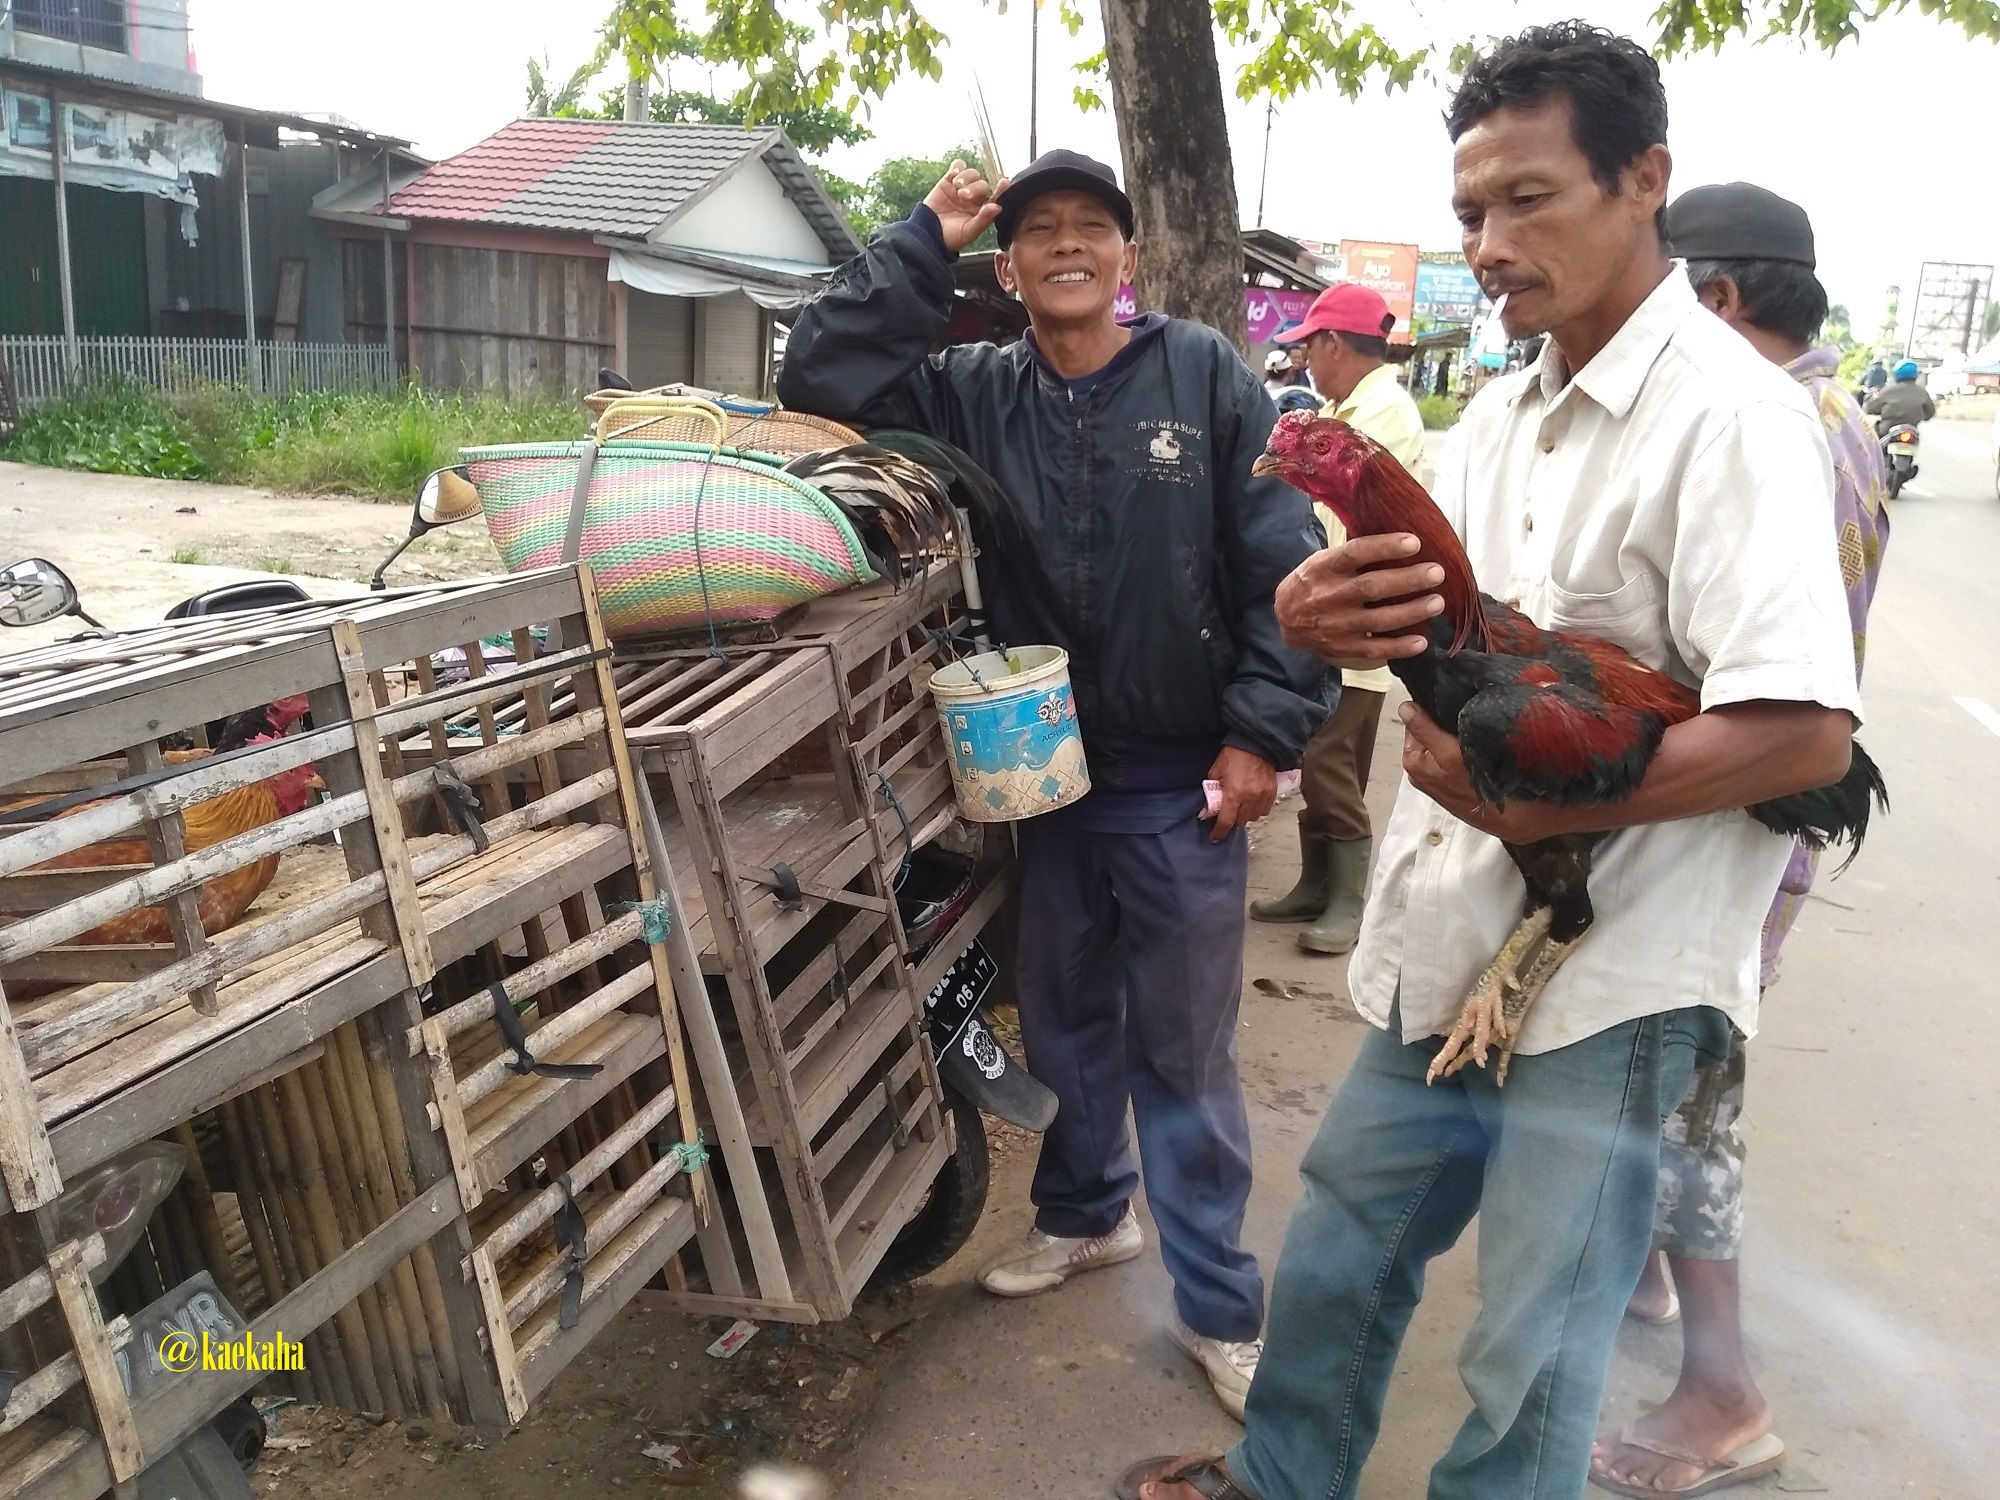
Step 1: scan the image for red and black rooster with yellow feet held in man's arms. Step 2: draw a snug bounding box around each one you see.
[1258,412,1886,1080]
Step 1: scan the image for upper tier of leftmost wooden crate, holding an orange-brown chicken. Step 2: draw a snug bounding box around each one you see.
[0,572,632,1208]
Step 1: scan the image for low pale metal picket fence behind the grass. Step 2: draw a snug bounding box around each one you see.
[0,334,396,408]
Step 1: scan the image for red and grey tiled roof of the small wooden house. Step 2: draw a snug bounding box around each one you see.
[390,120,772,238]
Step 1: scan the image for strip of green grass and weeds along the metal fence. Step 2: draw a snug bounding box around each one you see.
[0,380,588,502]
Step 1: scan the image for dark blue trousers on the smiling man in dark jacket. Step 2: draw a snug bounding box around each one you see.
[1016,812,1264,1340]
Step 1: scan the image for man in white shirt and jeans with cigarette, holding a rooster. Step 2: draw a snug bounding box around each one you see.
[1120,22,1866,1500]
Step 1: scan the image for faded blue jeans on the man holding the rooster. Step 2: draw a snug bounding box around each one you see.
[1228,1008,1728,1500]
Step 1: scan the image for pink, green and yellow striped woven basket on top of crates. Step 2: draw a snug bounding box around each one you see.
[460,426,876,636]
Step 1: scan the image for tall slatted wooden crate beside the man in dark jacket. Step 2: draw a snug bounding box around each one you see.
[616,568,964,1320]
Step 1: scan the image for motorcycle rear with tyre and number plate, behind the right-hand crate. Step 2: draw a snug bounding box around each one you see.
[878,846,1056,1280]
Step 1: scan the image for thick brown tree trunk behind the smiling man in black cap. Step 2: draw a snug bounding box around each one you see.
[1102,0,1250,352]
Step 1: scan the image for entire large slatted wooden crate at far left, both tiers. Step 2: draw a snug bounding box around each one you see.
[0,570,706,1500]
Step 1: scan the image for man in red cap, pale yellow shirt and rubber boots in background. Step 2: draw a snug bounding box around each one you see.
[1250,282,1424,954]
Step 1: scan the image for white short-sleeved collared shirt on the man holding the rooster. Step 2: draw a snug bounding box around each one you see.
[1350,264,1860,1054]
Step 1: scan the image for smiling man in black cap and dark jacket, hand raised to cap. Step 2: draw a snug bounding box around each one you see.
[778,150,1330,1416]
